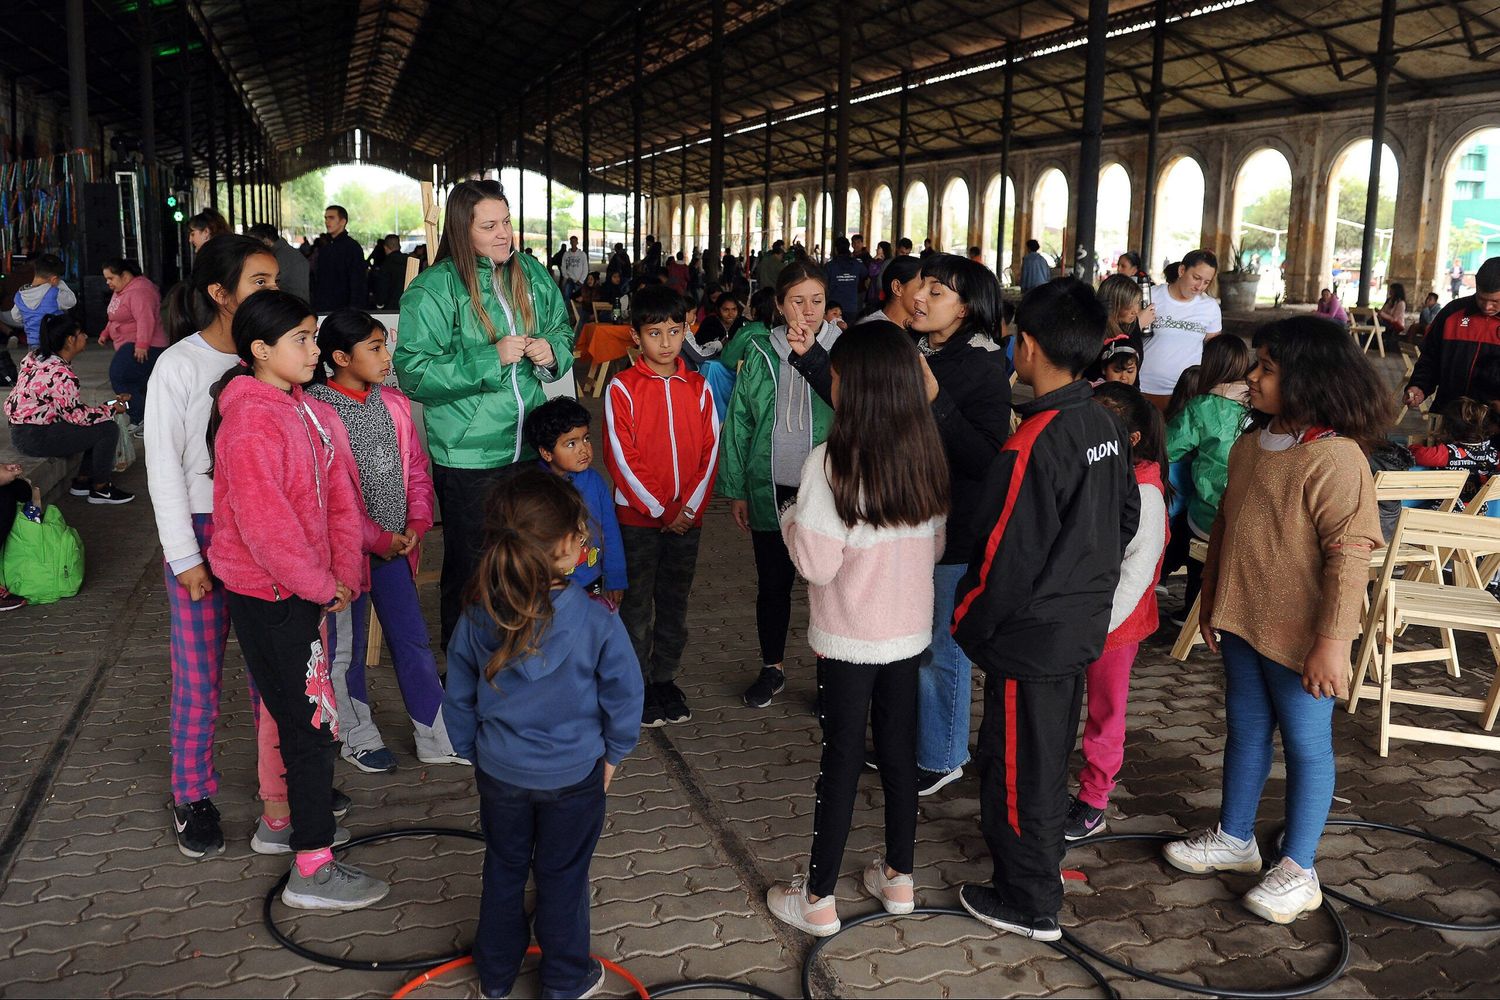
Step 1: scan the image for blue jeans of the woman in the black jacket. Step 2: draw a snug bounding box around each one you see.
[917,564,974,774]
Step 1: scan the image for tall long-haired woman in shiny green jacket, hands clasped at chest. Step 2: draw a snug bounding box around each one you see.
[395,180,573,649]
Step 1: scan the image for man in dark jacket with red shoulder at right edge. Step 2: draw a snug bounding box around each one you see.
[1406,256,1500,414]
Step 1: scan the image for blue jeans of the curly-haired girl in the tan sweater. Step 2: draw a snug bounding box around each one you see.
[1220,633,1335,868]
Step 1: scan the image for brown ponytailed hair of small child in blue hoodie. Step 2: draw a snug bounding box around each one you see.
[467,468,587,682]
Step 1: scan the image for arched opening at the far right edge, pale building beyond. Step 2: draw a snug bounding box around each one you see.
[1428,129,1500,299]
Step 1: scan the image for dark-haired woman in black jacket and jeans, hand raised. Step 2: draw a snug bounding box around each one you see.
[788,253,1011,795]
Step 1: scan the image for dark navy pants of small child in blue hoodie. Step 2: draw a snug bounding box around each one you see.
[474,760,605,997]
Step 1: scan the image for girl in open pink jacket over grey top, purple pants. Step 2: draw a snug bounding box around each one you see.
[308,309,470,772]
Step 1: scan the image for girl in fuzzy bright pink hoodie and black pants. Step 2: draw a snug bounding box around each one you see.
[209,291,390,910]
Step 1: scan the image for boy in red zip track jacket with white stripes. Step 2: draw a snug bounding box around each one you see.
[605,285,719,727]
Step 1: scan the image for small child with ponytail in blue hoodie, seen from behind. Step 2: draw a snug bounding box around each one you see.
[443,469,645,997]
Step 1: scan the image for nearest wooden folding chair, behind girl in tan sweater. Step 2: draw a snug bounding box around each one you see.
[1349,508,1500,757]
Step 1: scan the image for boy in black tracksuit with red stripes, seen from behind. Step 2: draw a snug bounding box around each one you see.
[953,277,1140,942]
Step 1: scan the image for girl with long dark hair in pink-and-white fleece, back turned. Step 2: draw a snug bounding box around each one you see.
[767,324,948,937]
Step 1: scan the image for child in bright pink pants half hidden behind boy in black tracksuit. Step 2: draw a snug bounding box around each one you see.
[1064,382,1167,841]
